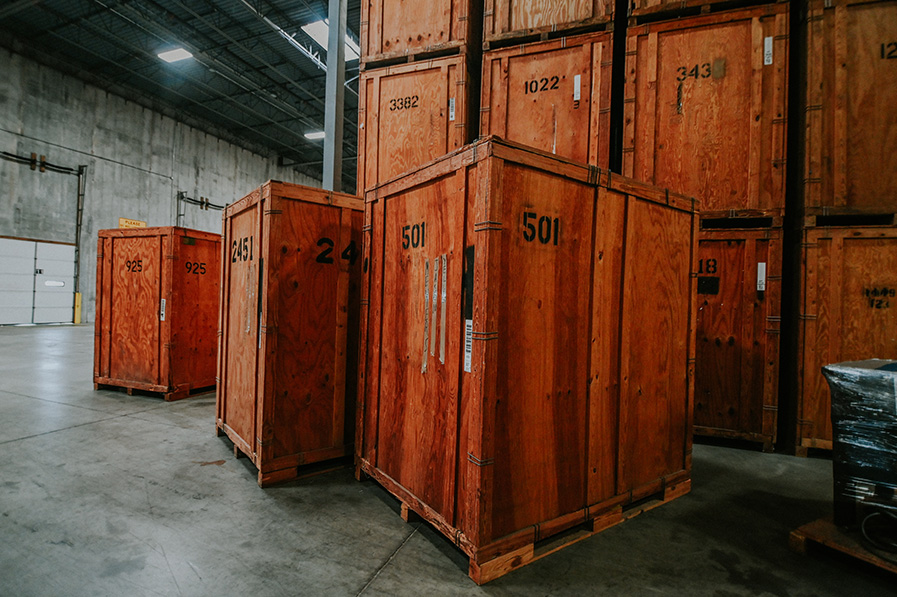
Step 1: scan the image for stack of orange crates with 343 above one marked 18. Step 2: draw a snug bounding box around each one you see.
[622,2,789,450]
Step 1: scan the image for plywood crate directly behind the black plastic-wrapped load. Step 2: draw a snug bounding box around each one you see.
[796,226,897,453]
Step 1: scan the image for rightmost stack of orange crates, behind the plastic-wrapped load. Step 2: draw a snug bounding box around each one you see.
[794,0,897,454]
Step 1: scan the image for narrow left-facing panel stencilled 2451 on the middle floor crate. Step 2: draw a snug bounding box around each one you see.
[221,204,262,444]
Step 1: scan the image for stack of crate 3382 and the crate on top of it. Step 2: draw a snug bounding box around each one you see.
[357,0,483,194]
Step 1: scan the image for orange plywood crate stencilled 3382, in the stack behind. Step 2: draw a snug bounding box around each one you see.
[358,56,479,191]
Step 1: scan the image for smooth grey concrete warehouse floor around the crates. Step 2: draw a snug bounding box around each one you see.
[0,326,897,597]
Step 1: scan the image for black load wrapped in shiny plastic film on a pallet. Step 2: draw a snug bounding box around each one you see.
[822,359,897,526]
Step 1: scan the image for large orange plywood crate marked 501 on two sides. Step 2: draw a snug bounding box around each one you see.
[356,137,696,583]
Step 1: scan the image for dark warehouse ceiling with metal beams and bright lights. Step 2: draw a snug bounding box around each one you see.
[0,0,360,190]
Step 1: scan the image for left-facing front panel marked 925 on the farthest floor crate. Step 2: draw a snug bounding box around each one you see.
[109,236,162,385]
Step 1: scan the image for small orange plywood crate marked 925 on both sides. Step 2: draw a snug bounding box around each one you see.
[93,226,221,400]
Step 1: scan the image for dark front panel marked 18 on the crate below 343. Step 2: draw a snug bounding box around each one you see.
[695,239,766,433]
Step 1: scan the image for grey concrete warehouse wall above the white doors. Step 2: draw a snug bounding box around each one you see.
[0,49,320,321]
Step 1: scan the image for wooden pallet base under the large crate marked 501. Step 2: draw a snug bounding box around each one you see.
[388,478,691,585]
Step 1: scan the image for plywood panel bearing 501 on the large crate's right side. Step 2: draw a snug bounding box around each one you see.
[487,164,595,538]
